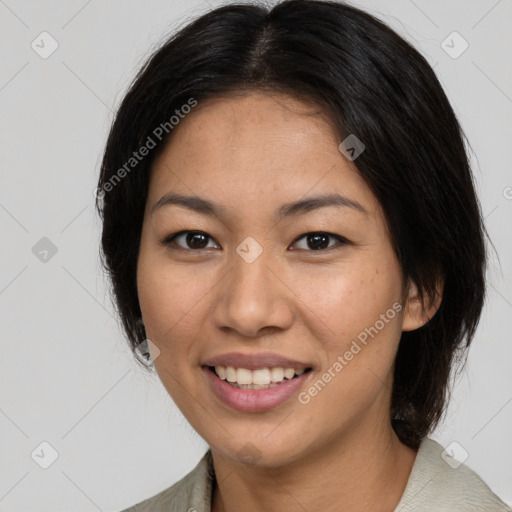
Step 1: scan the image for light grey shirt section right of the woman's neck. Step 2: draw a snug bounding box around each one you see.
[395,438,512,512]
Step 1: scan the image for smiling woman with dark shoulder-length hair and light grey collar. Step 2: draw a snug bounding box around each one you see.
[97,0,510,512]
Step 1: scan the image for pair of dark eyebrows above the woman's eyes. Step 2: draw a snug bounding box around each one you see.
[151,192,368,219]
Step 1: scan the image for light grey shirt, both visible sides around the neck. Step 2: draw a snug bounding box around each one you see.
[122,438,512,512]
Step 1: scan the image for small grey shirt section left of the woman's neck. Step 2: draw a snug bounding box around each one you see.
[121,450,214,512]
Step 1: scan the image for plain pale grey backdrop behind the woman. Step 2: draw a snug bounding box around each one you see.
[0,0,512,512]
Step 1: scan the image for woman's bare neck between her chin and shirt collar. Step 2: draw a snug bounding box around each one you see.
[211,423,416,512]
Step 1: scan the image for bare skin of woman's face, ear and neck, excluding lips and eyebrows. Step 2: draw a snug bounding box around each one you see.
[137,92,439,512]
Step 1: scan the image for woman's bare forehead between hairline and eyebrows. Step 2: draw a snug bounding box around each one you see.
[150,92,377,219]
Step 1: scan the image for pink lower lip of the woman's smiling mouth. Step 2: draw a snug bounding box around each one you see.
[202,367,312,412]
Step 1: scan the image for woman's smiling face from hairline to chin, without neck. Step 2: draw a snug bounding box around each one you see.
[137,92,416,467]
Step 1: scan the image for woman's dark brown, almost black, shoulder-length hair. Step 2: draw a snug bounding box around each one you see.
[96,0,486,447]
